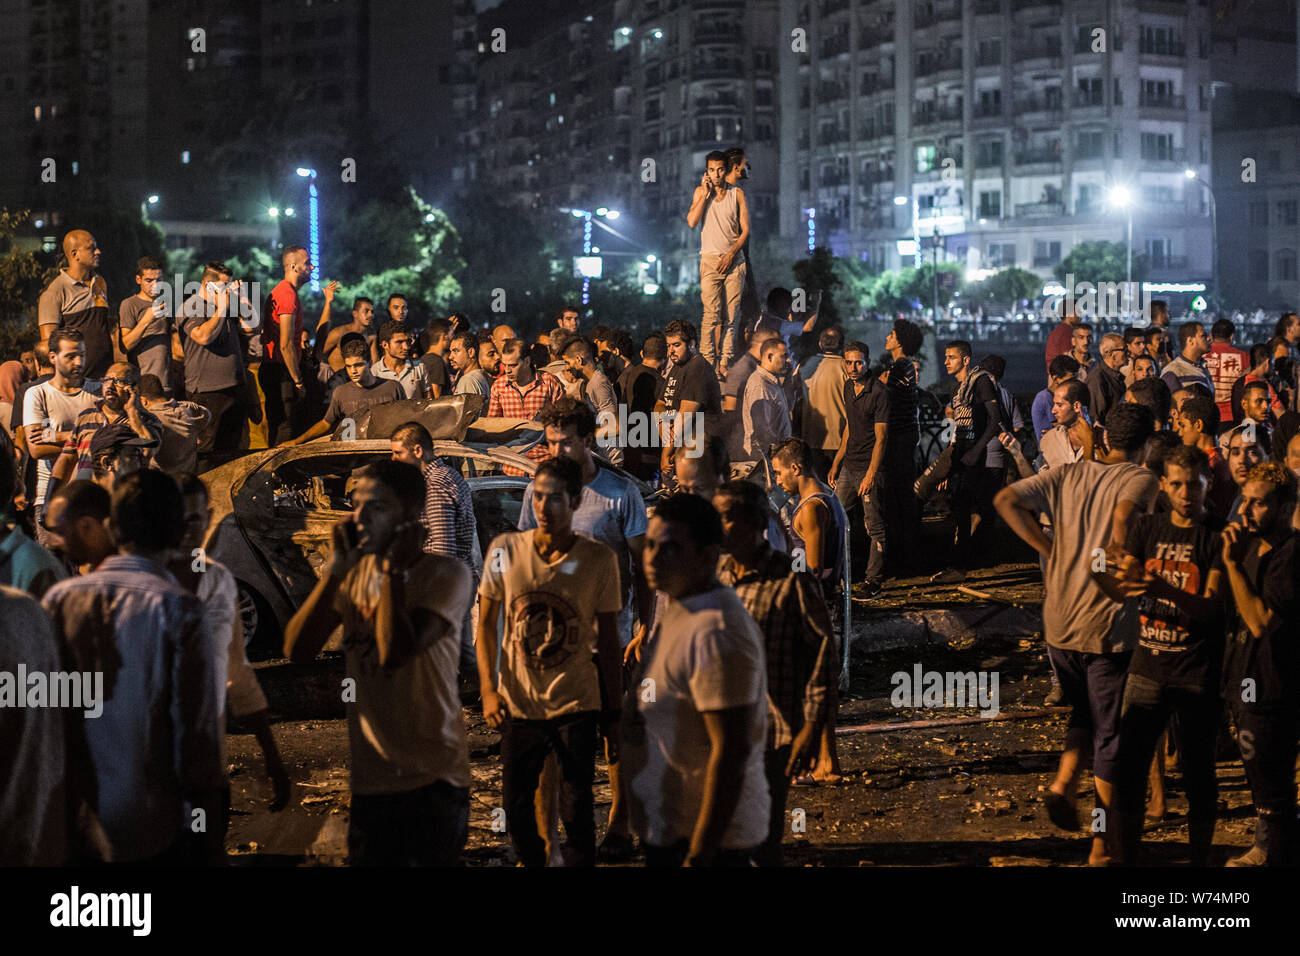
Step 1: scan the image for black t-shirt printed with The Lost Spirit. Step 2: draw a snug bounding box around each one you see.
[1125,514,1225,691]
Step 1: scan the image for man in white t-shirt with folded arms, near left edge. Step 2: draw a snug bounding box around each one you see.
[22,329,99,544]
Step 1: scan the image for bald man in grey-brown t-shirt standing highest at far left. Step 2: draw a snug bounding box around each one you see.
[36,229,126,381]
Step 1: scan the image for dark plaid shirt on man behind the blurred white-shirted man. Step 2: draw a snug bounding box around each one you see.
[718,542,839,749]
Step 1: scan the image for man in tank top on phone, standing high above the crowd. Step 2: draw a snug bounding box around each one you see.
[686,150,749,378]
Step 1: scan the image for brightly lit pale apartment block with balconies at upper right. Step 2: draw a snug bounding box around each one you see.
[780,0,1212,291]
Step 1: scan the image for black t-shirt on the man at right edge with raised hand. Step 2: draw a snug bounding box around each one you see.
[1223,528,1300,704]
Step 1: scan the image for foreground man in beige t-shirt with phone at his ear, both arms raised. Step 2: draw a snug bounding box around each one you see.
[285,460,472,866]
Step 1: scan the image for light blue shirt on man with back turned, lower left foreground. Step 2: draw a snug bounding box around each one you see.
[43,554,225,862]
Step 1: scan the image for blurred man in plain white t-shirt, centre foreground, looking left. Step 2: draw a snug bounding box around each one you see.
[623,494,770,866]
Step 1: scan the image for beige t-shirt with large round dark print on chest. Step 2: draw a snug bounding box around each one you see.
[478,529,621,721]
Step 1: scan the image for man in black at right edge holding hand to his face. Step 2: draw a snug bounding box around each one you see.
[1222,462,1300,866]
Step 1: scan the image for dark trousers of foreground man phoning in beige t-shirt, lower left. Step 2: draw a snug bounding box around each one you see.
[347,780,469,866]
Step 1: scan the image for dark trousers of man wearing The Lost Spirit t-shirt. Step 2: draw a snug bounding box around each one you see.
[1114,674,1222,866]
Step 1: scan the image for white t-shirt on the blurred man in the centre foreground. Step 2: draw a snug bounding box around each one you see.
[621,587,770,849]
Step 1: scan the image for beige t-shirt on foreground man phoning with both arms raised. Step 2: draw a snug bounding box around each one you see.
[334,554,473,795]
